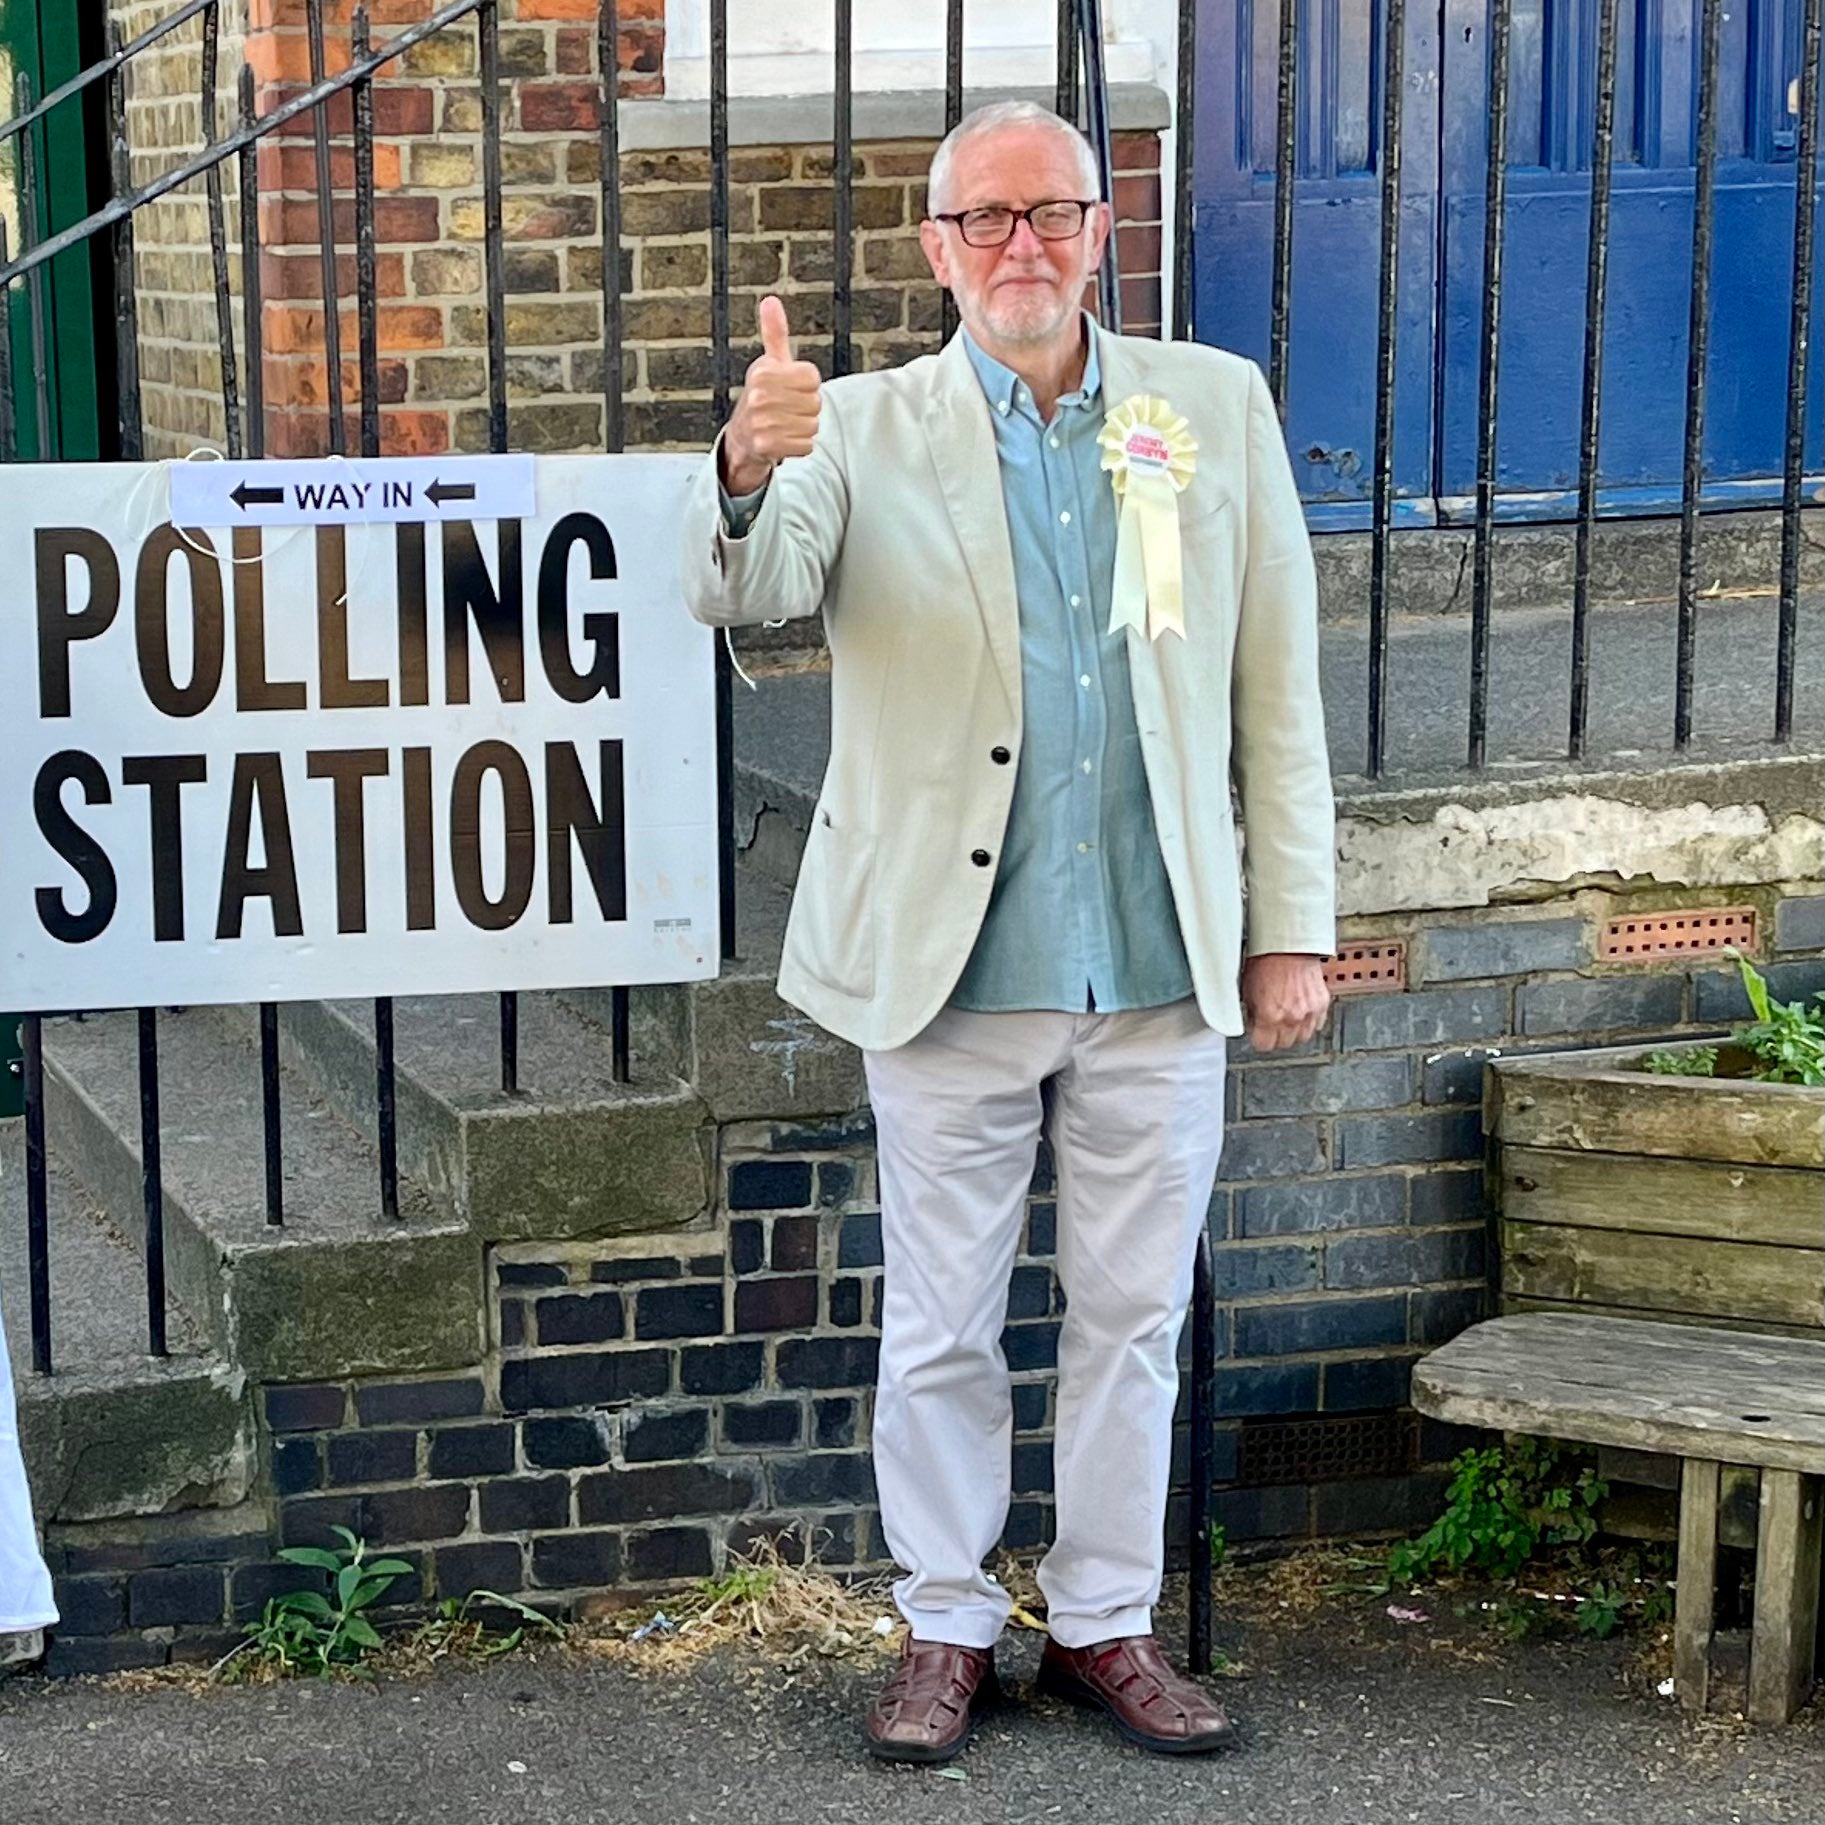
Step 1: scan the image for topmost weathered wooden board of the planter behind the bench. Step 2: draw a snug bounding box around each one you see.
[1484,1048,1825,1172]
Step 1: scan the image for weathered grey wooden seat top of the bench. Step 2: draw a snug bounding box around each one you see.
[1413,1314,1825,1475]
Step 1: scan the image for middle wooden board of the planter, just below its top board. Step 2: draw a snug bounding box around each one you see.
[1502,1144,1825,1248]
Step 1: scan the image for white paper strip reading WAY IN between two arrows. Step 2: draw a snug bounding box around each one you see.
[164,454,537,526]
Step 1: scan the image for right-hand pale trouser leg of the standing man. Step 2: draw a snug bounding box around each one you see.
[1038,1000,1225,1648]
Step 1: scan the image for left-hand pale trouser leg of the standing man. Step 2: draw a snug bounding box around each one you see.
[865,1009,1075,1648]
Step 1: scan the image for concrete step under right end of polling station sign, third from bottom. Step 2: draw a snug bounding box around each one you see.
[251,995,710,1243]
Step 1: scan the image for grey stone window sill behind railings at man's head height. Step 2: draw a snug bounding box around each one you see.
[621,82,1172,151]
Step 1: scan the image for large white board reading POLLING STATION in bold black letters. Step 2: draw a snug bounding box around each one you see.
[0,456,717,1011]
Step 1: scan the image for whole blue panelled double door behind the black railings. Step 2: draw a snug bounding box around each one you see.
[1194,0,1825,526]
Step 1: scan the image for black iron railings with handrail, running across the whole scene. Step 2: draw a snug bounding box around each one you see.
[0,0,1825,1664]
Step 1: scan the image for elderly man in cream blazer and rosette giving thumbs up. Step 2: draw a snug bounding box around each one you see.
[684,102,1334,1761]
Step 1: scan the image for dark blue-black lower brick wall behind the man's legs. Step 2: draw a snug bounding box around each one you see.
[47,881,1825,1672]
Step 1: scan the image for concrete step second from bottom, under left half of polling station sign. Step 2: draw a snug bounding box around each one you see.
[44,1009,484,1382]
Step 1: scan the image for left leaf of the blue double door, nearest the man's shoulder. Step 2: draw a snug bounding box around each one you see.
[1194,0,1440,524]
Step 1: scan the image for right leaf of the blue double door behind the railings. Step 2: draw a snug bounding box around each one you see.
[1438,0,1825,516]
